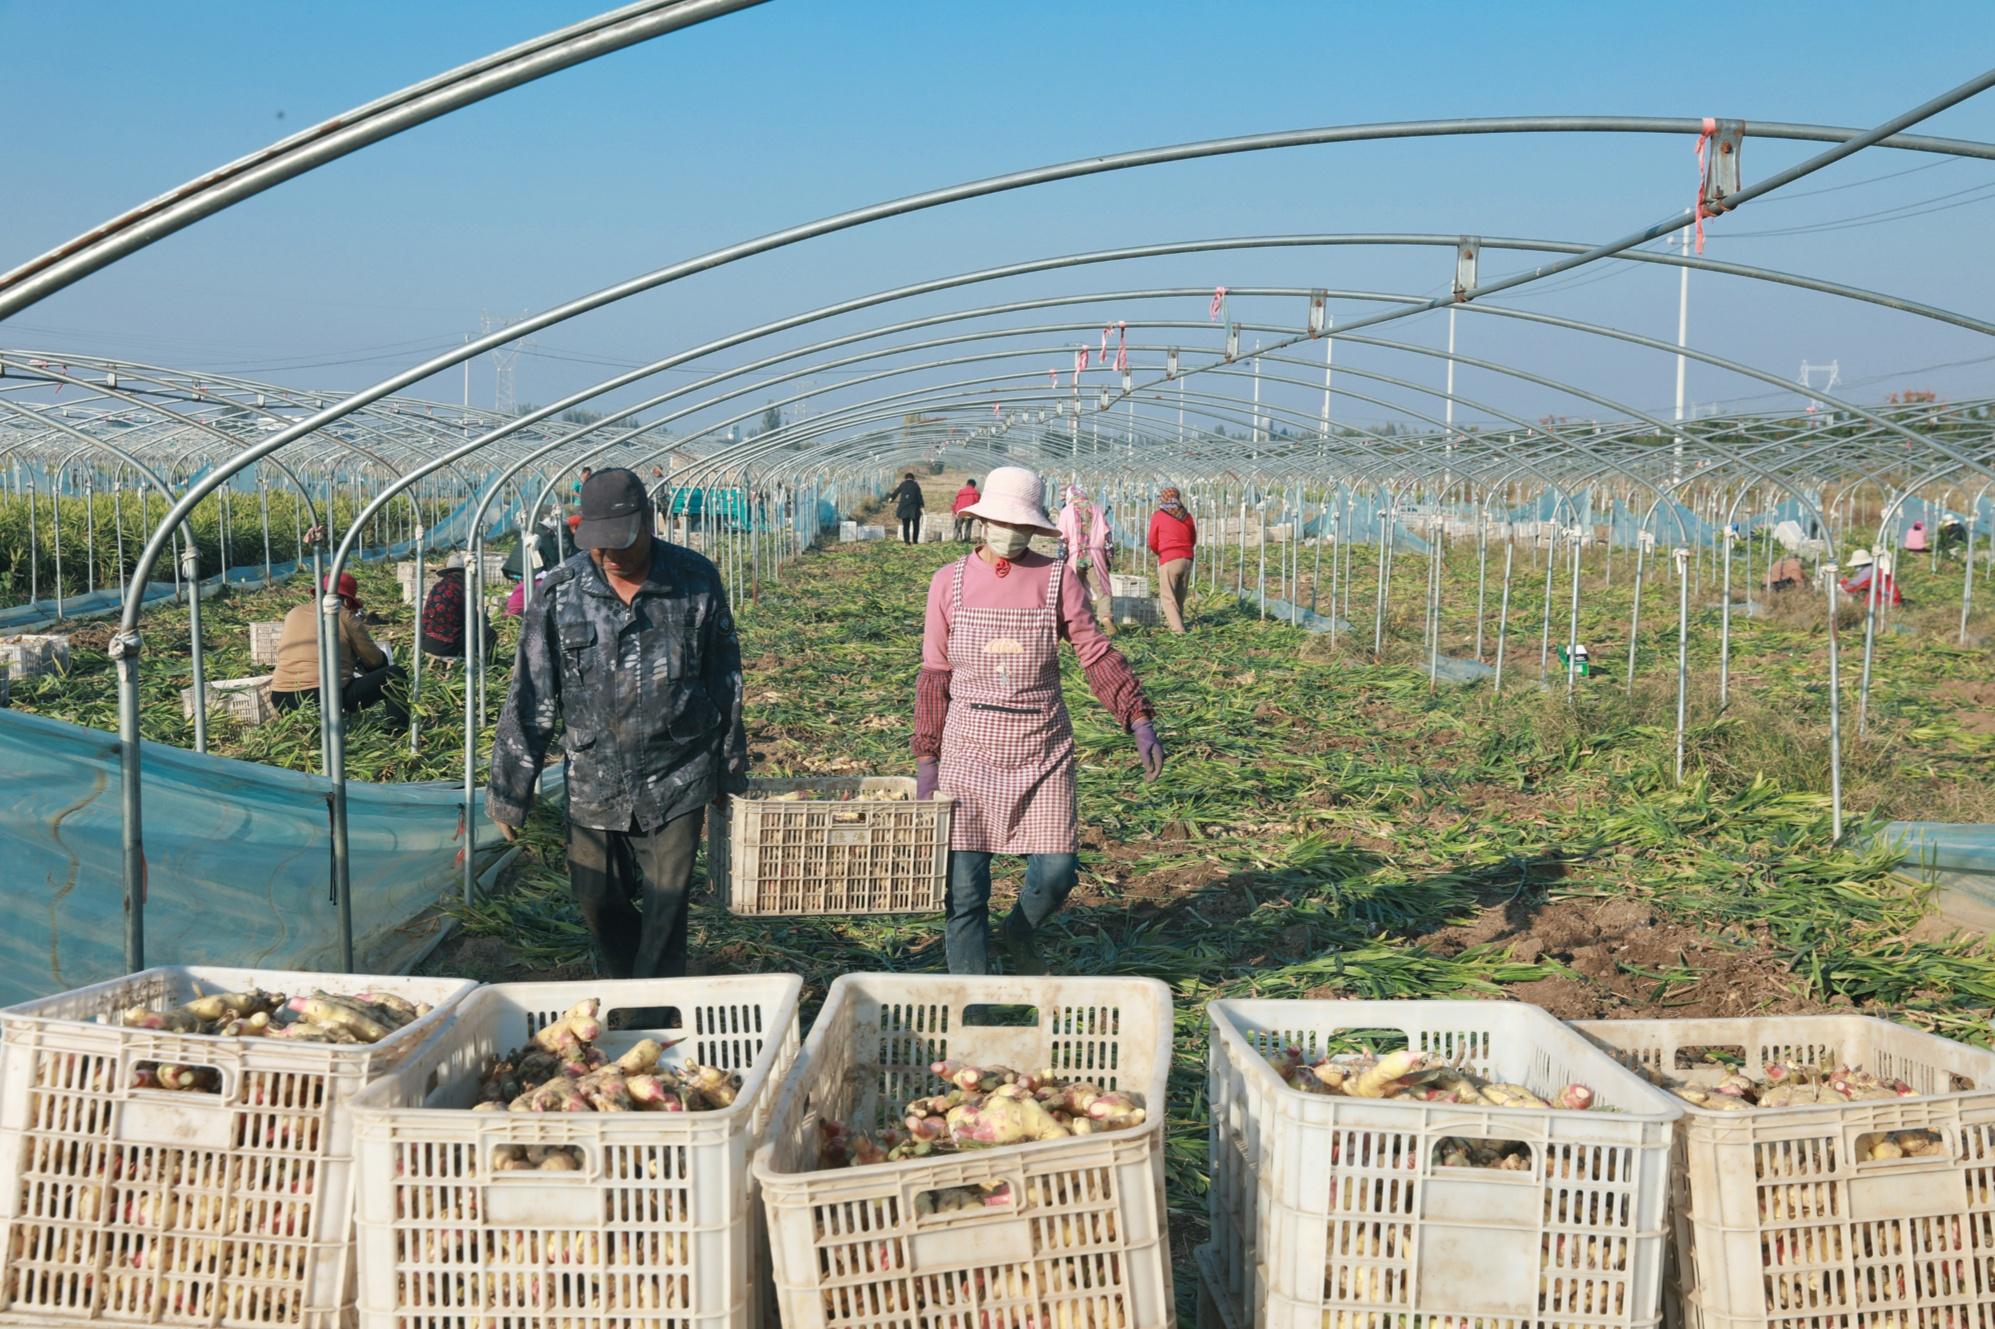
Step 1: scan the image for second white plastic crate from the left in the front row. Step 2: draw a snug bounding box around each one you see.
[355,974,804,1329]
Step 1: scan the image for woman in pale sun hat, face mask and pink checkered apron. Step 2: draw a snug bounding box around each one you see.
[914,467,1163,974]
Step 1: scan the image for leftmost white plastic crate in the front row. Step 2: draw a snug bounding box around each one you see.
[0,968,475,1329]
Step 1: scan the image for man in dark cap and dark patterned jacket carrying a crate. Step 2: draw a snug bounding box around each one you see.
[485,467,748,978]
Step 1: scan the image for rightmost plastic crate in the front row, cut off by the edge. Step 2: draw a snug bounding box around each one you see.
[1574,1016,1995,1329]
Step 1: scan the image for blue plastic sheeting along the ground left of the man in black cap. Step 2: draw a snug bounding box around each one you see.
[0,710,514,1004]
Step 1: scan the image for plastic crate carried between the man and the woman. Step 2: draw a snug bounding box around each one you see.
[706,776,956,914]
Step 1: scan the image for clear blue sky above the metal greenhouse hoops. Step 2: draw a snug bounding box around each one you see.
[0,0,1995,433]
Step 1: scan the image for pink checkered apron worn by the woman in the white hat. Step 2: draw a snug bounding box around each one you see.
[938,555,1079,854]
